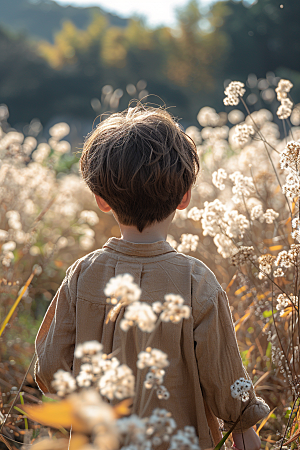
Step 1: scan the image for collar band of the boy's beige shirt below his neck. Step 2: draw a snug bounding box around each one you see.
[103,237,176,257]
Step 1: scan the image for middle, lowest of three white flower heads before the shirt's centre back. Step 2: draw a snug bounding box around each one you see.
[120,302,157,333]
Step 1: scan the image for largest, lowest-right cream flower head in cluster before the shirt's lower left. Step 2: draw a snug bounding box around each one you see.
[99,364,134,400]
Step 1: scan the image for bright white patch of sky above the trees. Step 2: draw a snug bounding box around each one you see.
[55,0,213,27]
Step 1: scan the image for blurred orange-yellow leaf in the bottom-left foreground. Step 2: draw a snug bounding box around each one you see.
[23,400,86,433]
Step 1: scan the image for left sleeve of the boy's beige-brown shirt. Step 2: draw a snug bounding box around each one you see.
[35,270,76,393]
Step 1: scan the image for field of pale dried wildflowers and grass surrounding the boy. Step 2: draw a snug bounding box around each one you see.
[0,78,300,450]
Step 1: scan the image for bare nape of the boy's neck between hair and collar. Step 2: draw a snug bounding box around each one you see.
[119,213,174,244]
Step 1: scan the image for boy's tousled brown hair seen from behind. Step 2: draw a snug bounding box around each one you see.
[80,104,199,232]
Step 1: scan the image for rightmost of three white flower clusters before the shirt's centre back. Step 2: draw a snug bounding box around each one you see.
[152,294,191,323]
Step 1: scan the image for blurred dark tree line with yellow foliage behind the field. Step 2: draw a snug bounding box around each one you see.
[0,0,300,128]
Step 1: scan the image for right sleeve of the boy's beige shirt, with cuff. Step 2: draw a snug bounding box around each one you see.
[194,287,270,432]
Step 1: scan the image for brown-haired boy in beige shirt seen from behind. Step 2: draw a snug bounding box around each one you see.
[36,105,269,450]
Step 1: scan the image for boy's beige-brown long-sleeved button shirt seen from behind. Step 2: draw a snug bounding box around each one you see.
[36,238,269,449]
